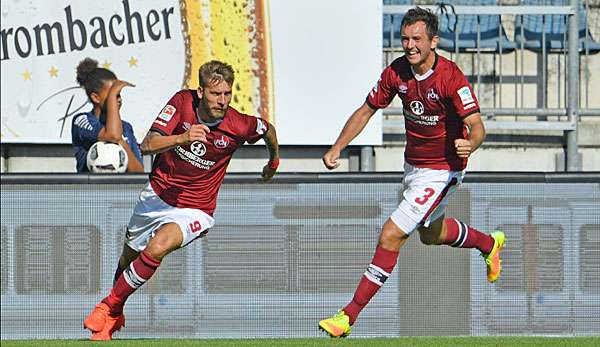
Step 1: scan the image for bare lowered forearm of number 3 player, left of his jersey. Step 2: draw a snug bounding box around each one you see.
[323,101,377,170]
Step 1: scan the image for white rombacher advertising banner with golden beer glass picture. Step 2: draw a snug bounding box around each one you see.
[0,0,382,145]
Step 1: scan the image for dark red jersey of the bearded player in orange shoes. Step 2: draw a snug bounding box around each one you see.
[150,90,269,216]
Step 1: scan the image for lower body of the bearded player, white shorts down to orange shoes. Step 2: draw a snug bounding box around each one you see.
[84,185,214,340]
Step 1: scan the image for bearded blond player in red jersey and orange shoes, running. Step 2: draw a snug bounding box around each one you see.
[84,61,279,340]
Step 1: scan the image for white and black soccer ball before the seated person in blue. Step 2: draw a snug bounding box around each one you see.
[87,141,129,173]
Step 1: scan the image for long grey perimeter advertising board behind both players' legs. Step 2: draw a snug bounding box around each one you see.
[0,173,600,340]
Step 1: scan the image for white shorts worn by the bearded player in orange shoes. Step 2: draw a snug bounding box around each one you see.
[125,183,215,252]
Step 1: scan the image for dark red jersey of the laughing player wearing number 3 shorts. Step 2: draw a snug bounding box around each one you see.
[367,54,479,171]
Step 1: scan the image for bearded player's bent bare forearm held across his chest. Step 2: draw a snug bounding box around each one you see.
[140,124,210,155]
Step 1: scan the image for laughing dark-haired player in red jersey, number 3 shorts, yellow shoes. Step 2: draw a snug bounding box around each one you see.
[319,7,505,337]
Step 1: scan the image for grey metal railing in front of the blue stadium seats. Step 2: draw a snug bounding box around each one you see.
[383,0,600,171]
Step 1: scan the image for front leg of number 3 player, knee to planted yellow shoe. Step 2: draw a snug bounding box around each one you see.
[319,222,408,337]
